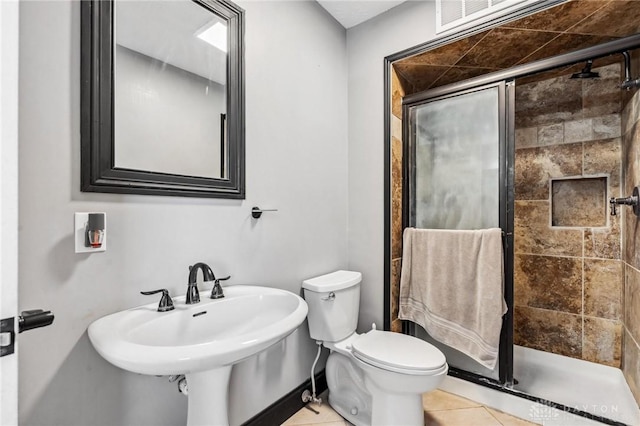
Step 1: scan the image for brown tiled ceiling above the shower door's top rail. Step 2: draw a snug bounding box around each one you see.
[394,0,640,94]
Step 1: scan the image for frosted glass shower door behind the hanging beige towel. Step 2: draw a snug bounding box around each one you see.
[404,82,511,383]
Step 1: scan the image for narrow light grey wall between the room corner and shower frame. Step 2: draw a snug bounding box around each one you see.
[347,1,435,331]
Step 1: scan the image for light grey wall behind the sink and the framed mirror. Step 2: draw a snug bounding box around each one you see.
[19,1,348,426]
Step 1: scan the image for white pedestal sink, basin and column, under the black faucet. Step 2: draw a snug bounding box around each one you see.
[88,285,307,426]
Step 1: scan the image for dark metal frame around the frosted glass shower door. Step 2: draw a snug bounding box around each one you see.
[402,80,515,386]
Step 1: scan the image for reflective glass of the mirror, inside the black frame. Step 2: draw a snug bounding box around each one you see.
[113,0,228,179]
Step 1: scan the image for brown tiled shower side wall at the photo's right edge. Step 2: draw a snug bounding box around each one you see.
[622,83,640,404]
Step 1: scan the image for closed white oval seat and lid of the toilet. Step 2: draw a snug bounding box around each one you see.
[351,330,447,375]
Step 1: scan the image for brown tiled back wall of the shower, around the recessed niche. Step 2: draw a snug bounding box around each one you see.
[514,64,623,367]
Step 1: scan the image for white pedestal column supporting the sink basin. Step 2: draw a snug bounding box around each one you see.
[186,365,232,426]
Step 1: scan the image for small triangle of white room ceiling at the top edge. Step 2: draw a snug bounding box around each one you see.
[318,0,404,28]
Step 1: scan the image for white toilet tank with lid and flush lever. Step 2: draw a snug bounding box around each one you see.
[302,271,362,342]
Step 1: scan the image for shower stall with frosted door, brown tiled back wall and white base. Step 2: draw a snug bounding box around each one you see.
[386,37,640,425]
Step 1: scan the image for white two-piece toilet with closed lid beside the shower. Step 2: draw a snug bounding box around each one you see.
[302,271,449,426]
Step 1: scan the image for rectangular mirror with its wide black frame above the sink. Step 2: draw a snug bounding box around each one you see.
[81,0,245,199]
